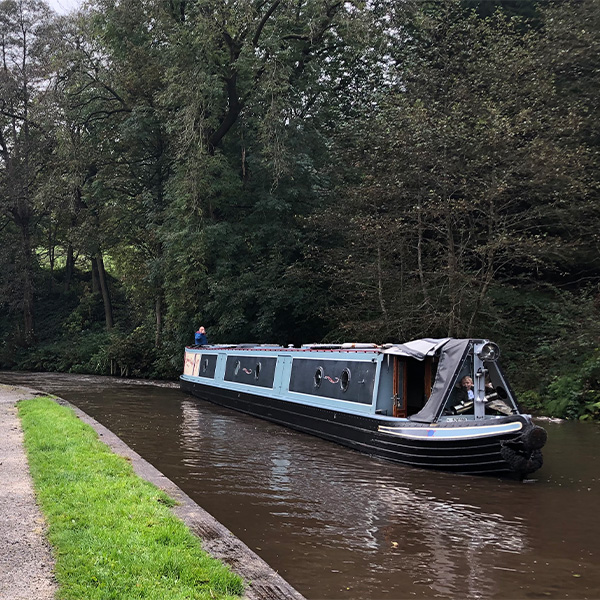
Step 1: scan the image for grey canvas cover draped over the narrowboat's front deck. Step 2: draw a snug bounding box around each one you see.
[384,338,473,423]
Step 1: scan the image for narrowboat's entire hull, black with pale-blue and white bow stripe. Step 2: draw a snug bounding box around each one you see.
[181,378,541,478]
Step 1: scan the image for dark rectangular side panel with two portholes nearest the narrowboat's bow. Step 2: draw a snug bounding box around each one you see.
[290,358,376,404]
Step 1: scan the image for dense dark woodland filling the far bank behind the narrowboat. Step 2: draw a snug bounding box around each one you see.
[0,0,600,418]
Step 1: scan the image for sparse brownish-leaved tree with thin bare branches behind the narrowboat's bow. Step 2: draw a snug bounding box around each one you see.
[316,2,564,339]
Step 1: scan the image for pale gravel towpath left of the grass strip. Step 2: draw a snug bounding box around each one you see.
[0,384,57,600]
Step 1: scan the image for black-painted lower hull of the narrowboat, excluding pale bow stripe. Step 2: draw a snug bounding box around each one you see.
[181,379,534,478]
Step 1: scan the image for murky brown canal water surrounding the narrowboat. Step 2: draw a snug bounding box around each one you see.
[0,373,600,600]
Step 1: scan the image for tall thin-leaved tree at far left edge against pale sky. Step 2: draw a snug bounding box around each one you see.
[0,0,51,343]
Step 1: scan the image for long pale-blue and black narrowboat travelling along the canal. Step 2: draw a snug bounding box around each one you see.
[180,338,546,479]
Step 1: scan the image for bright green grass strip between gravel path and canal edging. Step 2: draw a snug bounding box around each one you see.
[19,398,243,600]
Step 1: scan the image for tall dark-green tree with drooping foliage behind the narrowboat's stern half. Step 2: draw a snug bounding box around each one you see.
[152,0,392,341]
